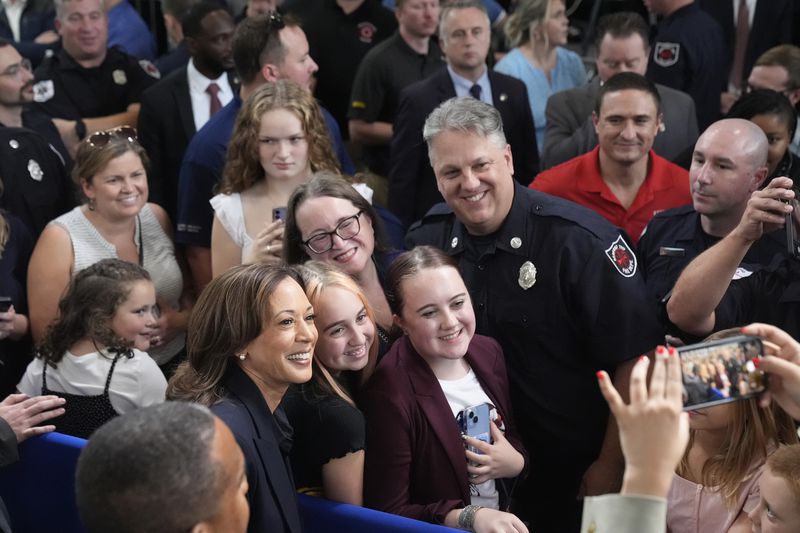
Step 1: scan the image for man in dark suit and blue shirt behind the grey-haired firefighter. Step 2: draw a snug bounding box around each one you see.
[389,1,539,225]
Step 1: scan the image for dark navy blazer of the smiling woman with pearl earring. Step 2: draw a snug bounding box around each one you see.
[211,364,301,533]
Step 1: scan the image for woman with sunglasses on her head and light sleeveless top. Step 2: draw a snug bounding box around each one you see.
[28,126,191,376]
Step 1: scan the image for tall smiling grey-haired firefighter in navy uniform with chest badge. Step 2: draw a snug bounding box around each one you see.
[407,97,663,533]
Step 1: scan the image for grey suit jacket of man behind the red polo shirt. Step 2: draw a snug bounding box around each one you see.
[542,78,698,169]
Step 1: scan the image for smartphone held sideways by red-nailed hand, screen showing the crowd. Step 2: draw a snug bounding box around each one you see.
[678,335,767,411]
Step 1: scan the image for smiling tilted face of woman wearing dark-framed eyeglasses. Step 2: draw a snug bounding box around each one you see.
[295,196,375,277]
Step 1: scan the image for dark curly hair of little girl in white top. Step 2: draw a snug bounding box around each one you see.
[36,259,151,368]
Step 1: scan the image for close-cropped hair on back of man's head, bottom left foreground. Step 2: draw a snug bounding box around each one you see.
[75,402,226,533]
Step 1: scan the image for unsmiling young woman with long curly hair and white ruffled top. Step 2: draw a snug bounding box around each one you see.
[211,80,338,277]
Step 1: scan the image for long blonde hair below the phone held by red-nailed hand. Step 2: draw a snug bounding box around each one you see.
[677,328,798,507]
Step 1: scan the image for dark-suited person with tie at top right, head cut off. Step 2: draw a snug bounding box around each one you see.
[699,0,793,113]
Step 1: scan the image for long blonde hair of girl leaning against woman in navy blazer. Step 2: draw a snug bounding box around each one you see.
[296,261,380,406]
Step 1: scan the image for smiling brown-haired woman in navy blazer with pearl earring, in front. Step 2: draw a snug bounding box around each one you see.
[167,264,317,533]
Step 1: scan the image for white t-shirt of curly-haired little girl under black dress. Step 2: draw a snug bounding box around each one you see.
[17,349,167,415]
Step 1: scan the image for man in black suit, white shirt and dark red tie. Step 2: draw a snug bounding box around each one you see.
[139,2,237,220]
